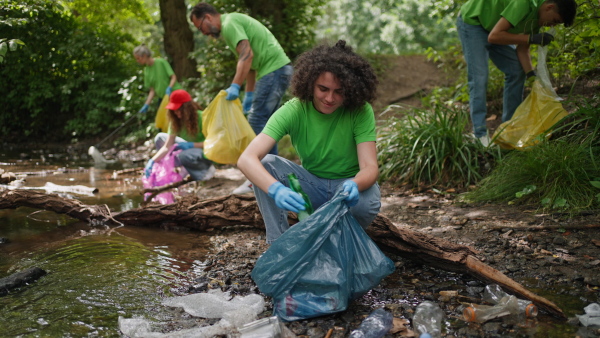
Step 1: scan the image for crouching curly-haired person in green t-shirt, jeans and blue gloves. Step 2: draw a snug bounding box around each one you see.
[238,40,381,243]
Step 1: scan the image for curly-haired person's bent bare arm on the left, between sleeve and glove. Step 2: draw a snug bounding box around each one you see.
[237,133,277,193]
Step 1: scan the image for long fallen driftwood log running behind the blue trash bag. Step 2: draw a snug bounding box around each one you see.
[0,191,566,318]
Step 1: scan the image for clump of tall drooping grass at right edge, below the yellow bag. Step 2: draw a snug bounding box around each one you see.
[464,100,600,212]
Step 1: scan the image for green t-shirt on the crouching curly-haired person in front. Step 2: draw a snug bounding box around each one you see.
[262,98,377,179]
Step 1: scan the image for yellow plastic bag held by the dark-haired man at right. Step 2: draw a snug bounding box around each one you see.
[492,46,568,150]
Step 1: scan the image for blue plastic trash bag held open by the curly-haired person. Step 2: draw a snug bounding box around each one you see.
[252,190,394,321]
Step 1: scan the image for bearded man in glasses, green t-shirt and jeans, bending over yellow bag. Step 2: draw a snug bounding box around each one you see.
[190,2,292,194]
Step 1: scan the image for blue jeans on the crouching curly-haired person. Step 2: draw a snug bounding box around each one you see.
[253,154,381,243]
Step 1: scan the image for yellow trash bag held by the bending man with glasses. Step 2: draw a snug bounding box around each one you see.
[202,90,256,164]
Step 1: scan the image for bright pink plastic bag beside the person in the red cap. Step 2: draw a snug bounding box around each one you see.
[142,144,185,204]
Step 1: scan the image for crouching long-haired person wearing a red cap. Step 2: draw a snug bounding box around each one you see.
[145,89,216,181]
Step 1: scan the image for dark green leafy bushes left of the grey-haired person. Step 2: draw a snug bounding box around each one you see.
[0,0,135,141]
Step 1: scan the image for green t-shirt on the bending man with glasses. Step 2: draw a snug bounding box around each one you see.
[221,13,290,80]
